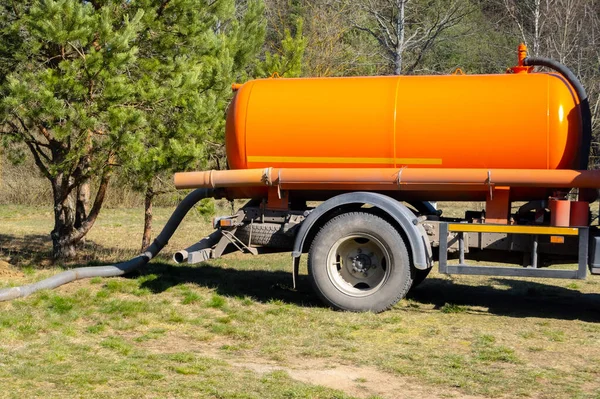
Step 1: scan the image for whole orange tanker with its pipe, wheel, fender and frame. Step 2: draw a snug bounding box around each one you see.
[174,46,600,312]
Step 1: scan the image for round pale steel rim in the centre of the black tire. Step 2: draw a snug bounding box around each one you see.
[327,233,391,297]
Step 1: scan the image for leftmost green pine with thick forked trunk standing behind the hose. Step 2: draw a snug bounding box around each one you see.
[0,0,143,258]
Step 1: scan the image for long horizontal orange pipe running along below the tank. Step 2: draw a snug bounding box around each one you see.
[175,168,600,192]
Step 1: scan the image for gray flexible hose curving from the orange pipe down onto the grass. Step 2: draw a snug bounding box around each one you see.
[0,188,213,302]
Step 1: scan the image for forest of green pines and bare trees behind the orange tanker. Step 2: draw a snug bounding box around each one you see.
[0,0,600,259]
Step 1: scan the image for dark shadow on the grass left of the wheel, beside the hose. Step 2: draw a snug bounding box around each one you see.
[141,263,323,307]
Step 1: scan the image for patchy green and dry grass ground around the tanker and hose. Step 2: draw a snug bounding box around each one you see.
[0,206,600,399]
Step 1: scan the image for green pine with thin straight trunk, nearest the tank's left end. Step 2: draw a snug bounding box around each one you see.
[122,0,265,248]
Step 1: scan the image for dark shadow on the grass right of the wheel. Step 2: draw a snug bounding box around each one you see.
[409,277,600,322]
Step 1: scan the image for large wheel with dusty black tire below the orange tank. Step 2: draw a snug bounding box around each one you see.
[308,212,412,313]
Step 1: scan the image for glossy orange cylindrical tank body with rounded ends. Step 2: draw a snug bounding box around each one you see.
[226,73,581,169]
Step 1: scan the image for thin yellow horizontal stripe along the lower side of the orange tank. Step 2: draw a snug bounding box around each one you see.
[248,155,442,165]
